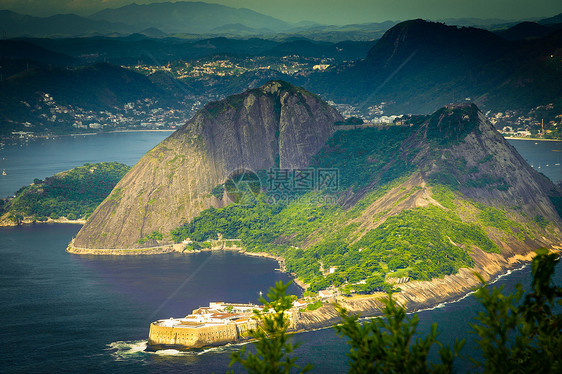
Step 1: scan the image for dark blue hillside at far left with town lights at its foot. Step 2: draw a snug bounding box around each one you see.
[0,60,188,136]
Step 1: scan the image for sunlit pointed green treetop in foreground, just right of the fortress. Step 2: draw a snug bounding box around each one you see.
[230,281,312,374]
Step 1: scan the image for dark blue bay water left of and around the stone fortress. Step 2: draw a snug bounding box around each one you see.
[0,224,300,373]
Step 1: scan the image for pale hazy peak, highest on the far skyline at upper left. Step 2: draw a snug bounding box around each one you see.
[90,1,290,34]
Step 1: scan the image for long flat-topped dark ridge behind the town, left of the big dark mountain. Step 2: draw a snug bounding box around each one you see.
[8,35,374,65]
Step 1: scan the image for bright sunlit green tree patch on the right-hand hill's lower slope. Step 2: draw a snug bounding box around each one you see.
[350,206,492,280]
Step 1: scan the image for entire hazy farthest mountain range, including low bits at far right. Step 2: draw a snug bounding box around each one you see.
[0,1,562,42]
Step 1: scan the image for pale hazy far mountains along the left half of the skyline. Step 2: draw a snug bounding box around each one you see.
[0,2,294,38]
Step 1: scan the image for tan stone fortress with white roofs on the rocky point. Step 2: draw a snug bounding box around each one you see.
[148,302,263,350]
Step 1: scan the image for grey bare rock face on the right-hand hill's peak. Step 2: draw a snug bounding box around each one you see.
[422,104,562,225]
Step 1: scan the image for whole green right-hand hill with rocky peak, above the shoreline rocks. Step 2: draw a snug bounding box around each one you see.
[167,105,562,293]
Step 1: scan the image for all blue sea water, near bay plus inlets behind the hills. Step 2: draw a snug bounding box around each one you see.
[0,133,562,373]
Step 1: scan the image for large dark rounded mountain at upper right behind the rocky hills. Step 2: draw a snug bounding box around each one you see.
[305,20,562,114]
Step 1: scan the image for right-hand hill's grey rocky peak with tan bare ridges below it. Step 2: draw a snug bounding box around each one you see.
[348,104,562,247]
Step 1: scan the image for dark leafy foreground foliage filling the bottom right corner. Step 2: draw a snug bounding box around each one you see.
[471,249,562,373]
